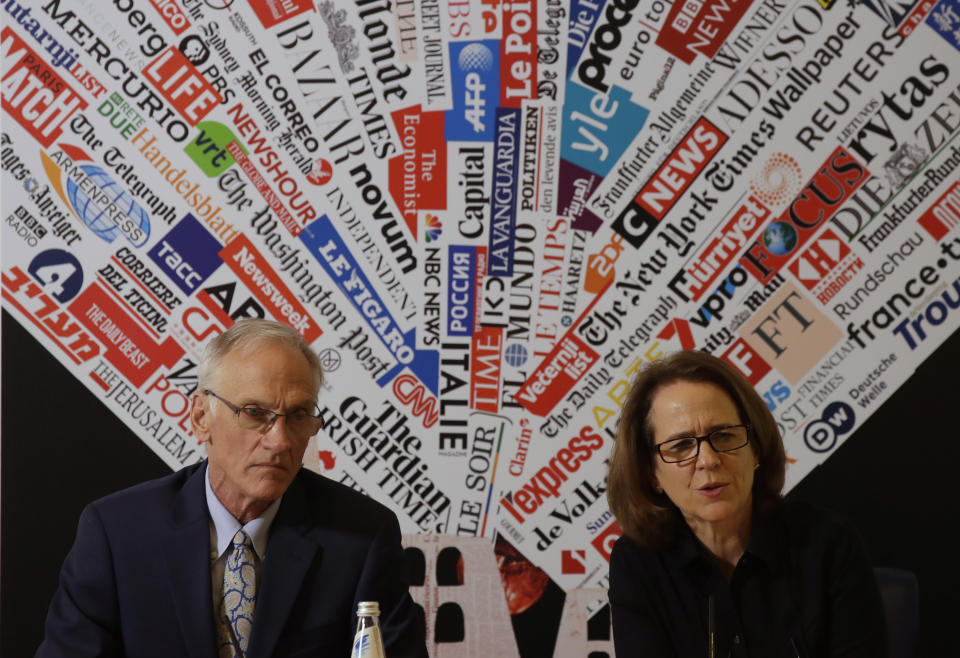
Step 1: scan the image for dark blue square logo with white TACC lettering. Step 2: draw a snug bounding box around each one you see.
[147,214,222,295]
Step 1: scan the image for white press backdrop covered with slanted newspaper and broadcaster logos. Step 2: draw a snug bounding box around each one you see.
[0,0,960,652]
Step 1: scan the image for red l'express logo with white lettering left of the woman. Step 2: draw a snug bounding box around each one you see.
[500,425,603,523]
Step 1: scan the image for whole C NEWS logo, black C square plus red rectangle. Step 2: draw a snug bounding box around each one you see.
[612,117,727,249]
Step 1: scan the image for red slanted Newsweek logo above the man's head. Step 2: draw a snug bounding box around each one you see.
[220,233,323,344]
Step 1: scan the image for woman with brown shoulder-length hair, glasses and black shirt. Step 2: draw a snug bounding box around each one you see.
[607,351,887,658]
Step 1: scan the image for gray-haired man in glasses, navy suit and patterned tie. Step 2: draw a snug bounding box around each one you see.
[37,319,427,658]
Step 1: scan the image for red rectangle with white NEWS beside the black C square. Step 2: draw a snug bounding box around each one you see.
[634,116,727,220]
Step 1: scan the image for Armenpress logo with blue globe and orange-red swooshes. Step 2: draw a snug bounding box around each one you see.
[40,144,150,247]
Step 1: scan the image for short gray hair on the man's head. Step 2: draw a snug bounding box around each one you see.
[197,318,323,392]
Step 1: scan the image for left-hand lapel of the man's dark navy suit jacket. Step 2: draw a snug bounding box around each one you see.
[163,462,217,658]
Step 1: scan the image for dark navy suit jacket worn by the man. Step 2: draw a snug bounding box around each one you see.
[37,462,427,658]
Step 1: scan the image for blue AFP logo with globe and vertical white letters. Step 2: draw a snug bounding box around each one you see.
[444,39,500,142]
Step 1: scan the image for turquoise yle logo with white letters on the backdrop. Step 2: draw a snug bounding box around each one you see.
[560,80,650,176]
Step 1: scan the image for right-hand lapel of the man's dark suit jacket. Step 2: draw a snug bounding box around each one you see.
[247,468,322,658]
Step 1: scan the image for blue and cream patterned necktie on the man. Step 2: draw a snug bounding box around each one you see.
[217,529,257,658]
